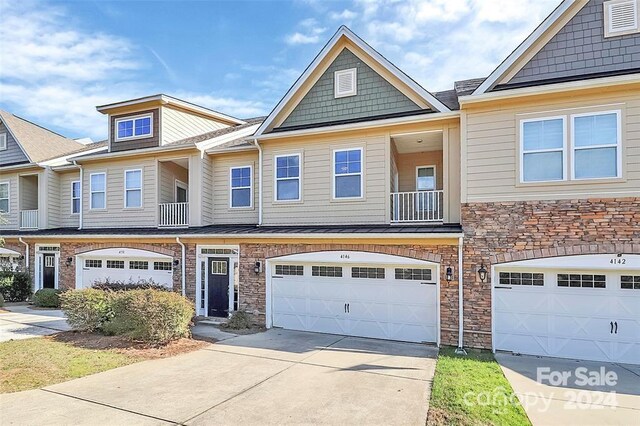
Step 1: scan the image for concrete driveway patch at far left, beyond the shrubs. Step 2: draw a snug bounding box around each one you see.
[0,305,70,342]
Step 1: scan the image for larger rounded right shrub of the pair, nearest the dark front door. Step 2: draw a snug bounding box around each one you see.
[104,289,194,343]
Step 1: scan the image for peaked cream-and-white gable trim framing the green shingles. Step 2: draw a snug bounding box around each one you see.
[256,25,450,136]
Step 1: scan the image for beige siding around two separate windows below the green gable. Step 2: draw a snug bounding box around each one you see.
[263,132,384,225]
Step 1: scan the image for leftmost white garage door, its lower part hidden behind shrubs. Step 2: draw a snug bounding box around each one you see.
[76,248,173,288]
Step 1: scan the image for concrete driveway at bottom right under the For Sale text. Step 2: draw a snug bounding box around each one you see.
[496,353,640,426]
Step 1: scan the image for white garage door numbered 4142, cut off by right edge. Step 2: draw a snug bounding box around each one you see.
[494,255,640,364]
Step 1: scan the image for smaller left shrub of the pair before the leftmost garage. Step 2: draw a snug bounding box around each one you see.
[60,288,114,331]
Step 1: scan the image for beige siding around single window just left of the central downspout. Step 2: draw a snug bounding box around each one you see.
[213,152,259,224]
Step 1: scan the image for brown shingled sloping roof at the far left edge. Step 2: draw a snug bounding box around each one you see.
[0,110,84,163]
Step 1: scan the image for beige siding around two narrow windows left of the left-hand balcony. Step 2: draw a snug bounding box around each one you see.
[83,158,158,228]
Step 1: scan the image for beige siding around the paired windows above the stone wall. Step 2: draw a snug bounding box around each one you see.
[464,89,640,202]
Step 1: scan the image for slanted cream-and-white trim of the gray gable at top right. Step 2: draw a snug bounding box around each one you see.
[473,0,588,95]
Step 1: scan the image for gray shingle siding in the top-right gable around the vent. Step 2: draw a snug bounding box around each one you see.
[507,0,640,84]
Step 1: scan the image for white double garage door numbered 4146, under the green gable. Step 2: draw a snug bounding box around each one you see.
[270,252,439,342]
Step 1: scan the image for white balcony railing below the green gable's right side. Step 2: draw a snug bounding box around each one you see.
[391,191,444,223]
